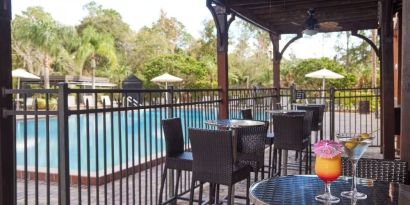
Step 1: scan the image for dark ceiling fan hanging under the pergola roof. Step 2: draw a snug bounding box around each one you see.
[291,8,342,35]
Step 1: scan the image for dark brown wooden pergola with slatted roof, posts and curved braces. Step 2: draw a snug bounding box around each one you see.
[0,0,410,205]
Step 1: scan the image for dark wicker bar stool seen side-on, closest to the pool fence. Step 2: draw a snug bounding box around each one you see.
[158,118,192,204]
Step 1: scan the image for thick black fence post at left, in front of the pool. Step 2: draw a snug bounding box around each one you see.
[58,83,70,205]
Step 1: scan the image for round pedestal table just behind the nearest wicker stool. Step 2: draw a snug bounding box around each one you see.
[205,119,265,204]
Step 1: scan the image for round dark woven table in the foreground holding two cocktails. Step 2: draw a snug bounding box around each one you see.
[250,175,410,205]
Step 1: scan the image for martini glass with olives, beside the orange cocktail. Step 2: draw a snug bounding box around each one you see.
[337,133,372,200]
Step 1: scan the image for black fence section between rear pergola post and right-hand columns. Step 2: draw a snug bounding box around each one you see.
[280,87,382,146]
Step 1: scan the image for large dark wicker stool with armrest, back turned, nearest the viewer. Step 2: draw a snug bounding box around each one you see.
[188,128,251,205]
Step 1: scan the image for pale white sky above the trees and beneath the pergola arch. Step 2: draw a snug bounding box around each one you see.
[12,0,342,58]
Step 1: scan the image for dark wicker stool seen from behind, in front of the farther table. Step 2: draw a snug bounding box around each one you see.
[272,111,312,175]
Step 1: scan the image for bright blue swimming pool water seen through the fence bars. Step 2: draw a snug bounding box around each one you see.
[16,110,215,173]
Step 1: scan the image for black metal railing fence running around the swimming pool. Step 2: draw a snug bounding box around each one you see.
[4,85,380,204]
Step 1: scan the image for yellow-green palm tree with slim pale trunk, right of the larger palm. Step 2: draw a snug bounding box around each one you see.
[76,26,117,89]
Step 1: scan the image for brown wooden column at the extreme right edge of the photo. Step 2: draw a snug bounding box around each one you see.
[400,0,410,176]
